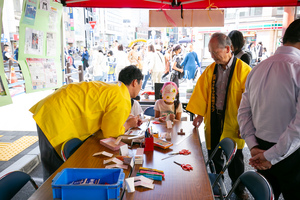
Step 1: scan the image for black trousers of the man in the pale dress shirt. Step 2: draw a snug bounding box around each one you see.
[256,138,300,200]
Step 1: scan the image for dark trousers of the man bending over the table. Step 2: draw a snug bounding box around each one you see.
[36,125,64,181]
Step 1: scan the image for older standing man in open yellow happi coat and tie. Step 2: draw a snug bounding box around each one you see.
[186,33,251,199]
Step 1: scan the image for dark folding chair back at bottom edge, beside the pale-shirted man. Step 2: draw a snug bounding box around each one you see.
[225,171,274,200]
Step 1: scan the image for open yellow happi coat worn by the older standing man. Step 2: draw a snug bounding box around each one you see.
[186,59,251,150]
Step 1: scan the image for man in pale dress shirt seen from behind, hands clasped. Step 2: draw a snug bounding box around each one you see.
[238,19,300,200]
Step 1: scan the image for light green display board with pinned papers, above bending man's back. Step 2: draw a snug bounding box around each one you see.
[19,0,63,93]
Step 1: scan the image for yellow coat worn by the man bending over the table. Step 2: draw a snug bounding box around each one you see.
[30,81,131,155]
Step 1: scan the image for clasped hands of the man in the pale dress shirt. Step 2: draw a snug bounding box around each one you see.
[249,147,272,170]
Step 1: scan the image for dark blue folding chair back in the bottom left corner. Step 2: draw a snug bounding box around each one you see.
[0,171,38,200]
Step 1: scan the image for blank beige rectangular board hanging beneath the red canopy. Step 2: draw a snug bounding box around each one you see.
[149,10,224,27]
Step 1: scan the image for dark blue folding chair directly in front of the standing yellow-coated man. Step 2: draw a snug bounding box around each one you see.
[206,138,237,199]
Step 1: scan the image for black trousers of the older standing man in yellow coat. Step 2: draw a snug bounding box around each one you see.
[207,115,245,193]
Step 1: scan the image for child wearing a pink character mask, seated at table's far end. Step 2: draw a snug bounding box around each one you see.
[154,82,182,121]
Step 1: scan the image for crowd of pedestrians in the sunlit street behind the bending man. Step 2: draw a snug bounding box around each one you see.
[65,40,201,90]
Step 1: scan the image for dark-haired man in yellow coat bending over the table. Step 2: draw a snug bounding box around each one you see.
[30,66,143,180]
